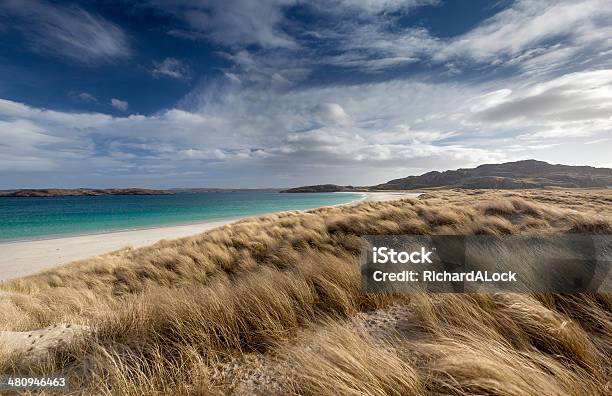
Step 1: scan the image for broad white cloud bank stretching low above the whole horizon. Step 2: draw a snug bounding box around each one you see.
[0,61,612,187]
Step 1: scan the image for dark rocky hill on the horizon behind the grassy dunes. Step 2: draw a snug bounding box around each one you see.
[285,160,612,192]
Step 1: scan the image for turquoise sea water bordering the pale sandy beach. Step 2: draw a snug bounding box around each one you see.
[0,192,361,241]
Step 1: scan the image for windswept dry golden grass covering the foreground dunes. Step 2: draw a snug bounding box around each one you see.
[0,190,612,395]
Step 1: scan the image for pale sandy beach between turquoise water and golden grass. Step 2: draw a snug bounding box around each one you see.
[0,192,418,282]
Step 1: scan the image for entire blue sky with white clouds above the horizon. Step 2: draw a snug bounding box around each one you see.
[0,0,612,189]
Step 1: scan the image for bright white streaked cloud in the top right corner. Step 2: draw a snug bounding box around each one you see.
[433,0,612,72]
